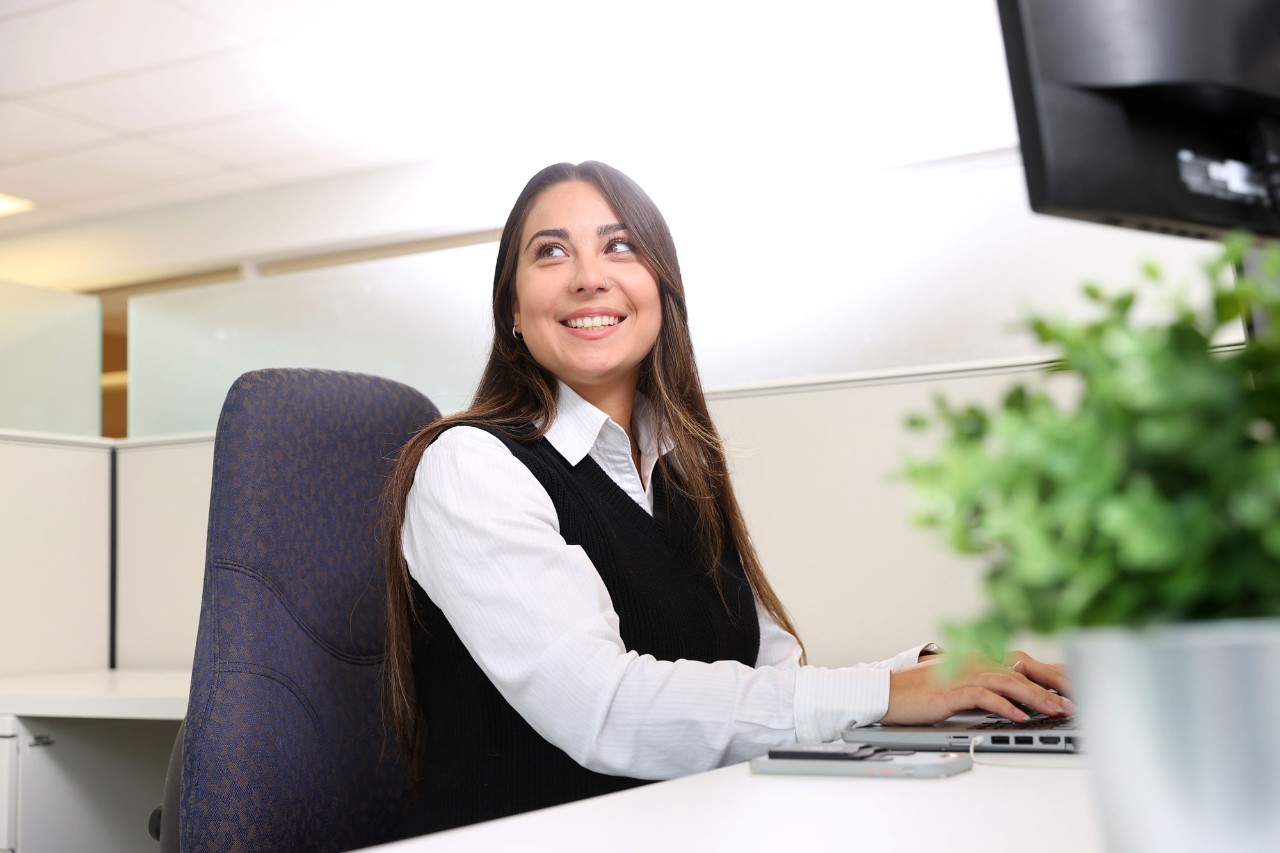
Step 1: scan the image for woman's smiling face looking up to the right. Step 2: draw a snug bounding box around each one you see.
[512,181,662,406]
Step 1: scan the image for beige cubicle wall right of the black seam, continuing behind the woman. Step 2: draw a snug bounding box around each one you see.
[116,371,1057,667]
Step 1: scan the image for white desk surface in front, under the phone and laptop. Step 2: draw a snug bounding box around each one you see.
[370,756,1103,853]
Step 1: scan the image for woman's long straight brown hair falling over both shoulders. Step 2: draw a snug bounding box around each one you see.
[383,161,795,771]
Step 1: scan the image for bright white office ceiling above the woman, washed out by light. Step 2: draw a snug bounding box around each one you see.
[0,0,1016,240]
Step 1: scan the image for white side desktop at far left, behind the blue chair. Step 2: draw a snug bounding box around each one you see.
[0,670,191,720]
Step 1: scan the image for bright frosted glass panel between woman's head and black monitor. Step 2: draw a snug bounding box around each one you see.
[672,155,1243,391]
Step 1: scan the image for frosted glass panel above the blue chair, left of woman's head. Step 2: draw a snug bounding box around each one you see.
[129,243,497,437]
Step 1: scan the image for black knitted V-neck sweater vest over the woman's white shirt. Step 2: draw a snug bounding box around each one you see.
[403,422,760,835]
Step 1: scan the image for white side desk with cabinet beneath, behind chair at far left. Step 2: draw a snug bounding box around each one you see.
[0,669,191,853]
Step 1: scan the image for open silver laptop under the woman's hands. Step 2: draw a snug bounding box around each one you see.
[841,710,1084,753]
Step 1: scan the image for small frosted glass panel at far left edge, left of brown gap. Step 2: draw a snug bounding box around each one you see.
[0,282,102,435]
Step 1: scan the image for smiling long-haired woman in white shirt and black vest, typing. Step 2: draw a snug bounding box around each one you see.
[387,163,1065,834]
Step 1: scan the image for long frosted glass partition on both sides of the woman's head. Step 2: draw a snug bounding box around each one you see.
[104,154,1243,437]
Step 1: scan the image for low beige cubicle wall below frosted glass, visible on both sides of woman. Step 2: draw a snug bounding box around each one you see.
[0,358,1080,674]
